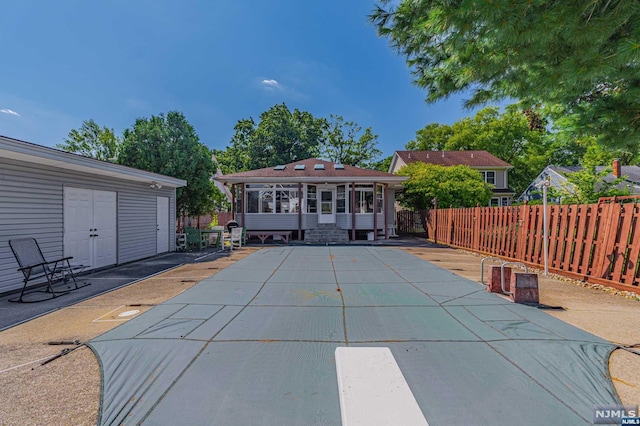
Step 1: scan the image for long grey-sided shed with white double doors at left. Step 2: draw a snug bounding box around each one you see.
[0,136,186,293]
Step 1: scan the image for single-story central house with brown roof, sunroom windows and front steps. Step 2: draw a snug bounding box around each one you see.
[215,158,406,243]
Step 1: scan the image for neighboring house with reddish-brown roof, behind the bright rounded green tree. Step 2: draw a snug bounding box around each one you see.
[389,151,515,206]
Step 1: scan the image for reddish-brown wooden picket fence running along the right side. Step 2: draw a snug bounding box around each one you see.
[427,200,640,293]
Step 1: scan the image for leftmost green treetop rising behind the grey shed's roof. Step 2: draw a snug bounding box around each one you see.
[56,119,122,163]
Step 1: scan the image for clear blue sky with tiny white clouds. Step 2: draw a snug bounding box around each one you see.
[0,0,484,159]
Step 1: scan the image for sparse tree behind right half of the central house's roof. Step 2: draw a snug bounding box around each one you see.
[320,114,382,167]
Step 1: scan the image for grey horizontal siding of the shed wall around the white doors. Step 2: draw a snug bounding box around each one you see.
[0,158,176,293]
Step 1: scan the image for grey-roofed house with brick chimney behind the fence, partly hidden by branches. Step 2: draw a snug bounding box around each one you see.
[518,160,640,204]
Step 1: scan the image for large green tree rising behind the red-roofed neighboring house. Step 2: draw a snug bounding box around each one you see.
[406,107,549,194]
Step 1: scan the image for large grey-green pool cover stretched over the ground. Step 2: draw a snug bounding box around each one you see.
[89,247,620,425]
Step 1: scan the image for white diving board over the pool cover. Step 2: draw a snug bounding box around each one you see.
[336,347,429,426]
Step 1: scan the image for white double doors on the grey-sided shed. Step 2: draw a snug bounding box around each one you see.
[63,187,117,269]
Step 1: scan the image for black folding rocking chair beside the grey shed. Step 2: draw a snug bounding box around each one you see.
[9,238,90,303]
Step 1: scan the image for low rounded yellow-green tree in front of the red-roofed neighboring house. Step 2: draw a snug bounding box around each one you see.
[397,163,492,210]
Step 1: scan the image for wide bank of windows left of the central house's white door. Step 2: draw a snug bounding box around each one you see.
[246,184,300,213]
